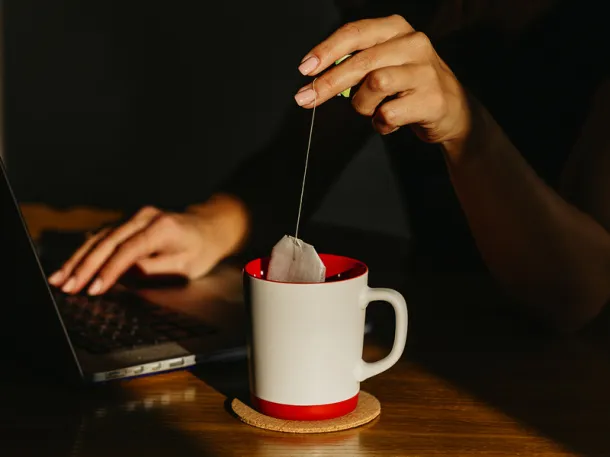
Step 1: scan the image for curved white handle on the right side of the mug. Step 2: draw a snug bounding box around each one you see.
[355,287,409,382]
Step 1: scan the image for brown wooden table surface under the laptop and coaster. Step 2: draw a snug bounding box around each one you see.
[0,206,610,457]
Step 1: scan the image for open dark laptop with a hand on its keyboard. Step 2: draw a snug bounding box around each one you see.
[0,159,246,384]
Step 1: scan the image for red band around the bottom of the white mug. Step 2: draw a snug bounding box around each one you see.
[251,394,358,421]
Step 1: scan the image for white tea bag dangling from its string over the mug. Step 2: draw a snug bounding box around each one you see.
[267,235,326,283]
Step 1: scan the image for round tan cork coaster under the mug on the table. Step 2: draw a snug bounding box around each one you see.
[231,391,381,433]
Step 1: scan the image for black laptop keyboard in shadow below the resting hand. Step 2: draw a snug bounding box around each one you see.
[55,292,216,354]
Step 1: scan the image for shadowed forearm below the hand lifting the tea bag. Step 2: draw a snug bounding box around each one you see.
[444,96,610,331]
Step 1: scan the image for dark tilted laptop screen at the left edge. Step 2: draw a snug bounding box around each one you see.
[0,159,82,382]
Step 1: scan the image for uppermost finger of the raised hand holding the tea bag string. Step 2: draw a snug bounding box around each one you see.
[299,14,414,76]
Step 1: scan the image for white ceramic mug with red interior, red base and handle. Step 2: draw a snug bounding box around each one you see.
[244,254,408,420]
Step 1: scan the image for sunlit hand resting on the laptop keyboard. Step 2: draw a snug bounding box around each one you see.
[49,195,248,295]
